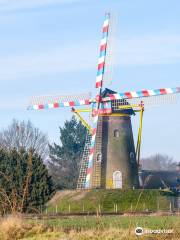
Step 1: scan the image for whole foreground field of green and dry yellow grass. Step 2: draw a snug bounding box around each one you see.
[0,216,180,240]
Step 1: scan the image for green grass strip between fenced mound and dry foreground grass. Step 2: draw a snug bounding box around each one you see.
[35,216,180,231]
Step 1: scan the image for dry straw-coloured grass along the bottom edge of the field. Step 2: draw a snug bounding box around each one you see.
[0,215,180,240]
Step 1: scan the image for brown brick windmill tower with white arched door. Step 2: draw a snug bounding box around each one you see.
[87,86,139,189]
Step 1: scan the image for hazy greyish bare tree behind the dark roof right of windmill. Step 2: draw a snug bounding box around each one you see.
[141,154,177,171]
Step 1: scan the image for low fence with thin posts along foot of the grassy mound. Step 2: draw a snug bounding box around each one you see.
[38,197,180,215]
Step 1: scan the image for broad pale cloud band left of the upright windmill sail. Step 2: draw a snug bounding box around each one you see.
[0,43,97,80]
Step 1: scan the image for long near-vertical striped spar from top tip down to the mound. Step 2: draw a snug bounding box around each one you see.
[85,13,110,188]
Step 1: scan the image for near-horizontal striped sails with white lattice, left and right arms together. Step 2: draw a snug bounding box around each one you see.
[28,87,180,110]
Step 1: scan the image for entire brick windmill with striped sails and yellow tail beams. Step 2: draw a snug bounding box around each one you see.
[28,13,180,189]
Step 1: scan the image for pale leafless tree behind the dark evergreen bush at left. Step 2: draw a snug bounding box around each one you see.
[0,119,49,158]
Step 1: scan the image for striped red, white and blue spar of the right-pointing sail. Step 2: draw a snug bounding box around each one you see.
[102,87,180,102]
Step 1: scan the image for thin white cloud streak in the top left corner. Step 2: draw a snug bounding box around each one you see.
[0,0,80,11]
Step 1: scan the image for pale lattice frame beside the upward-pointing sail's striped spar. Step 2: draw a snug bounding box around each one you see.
[103,13,118,86]
